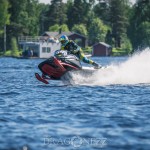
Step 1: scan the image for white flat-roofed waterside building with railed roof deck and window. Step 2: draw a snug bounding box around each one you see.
[18,36,60,58]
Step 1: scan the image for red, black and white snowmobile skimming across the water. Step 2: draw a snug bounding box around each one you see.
[35,50,99,84]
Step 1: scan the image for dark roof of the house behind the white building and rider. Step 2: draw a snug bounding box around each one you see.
[42,31,85,38]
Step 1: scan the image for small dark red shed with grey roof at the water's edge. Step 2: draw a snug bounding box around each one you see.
[92,42,112,56]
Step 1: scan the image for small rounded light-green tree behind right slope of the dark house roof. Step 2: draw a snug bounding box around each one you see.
[72,24,87,36]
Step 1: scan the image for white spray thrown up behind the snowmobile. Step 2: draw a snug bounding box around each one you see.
[68,48,150,86]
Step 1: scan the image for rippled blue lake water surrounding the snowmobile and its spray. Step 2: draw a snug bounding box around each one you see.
[0,57,150,150]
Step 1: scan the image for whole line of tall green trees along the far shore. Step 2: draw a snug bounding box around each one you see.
[0,0,150,52]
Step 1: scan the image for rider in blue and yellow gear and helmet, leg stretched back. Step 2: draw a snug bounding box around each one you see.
[59,35,101,69]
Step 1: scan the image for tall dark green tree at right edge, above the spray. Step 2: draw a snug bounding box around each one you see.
[128,0,150,50]
